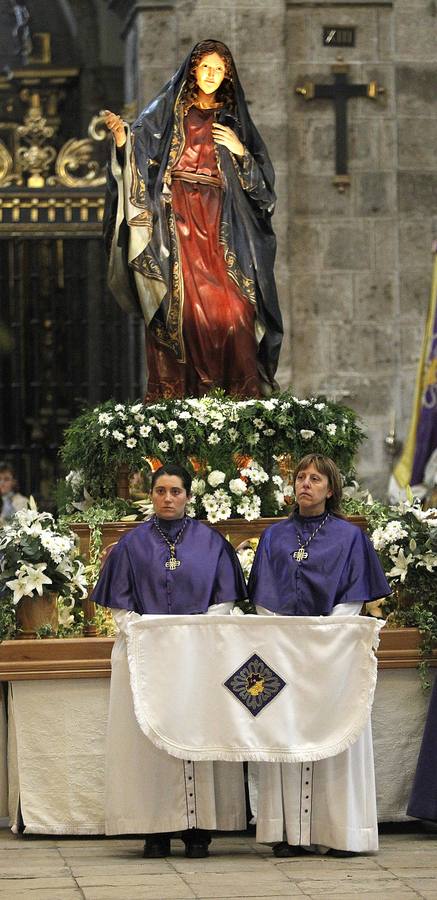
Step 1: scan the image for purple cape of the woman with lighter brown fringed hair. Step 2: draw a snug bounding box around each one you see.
[249,514,391,616]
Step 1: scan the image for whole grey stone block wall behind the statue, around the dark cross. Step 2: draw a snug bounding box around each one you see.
[109,0,437,495]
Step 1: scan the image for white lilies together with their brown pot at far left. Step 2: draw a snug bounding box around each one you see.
[0,498,88,640]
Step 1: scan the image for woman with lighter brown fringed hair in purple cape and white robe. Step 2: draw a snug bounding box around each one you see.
[249,454,391,857]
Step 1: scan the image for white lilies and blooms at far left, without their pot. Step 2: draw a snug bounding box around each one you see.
[0,498,88,606]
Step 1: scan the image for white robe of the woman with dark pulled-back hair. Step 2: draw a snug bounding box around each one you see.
[105,604,246,835]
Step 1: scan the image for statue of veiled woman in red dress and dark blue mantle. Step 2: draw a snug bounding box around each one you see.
[106,40,282,400]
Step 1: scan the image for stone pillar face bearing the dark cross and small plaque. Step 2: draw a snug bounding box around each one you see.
[287,0,400,487]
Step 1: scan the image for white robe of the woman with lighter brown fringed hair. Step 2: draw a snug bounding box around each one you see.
[256,603,378,853]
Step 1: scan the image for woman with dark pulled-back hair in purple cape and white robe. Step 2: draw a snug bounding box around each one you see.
[93,464,246,858]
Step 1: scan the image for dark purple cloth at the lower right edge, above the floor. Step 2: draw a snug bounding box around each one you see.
[407,678,437,822]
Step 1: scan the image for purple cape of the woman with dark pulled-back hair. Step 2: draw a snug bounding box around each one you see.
[91,519,247,615]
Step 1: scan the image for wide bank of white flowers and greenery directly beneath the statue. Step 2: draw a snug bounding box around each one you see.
[61,392,362,517]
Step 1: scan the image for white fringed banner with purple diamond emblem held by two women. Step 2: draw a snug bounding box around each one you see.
[127,616,383,762]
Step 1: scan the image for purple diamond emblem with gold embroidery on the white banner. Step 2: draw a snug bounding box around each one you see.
[223,653,286,716]
